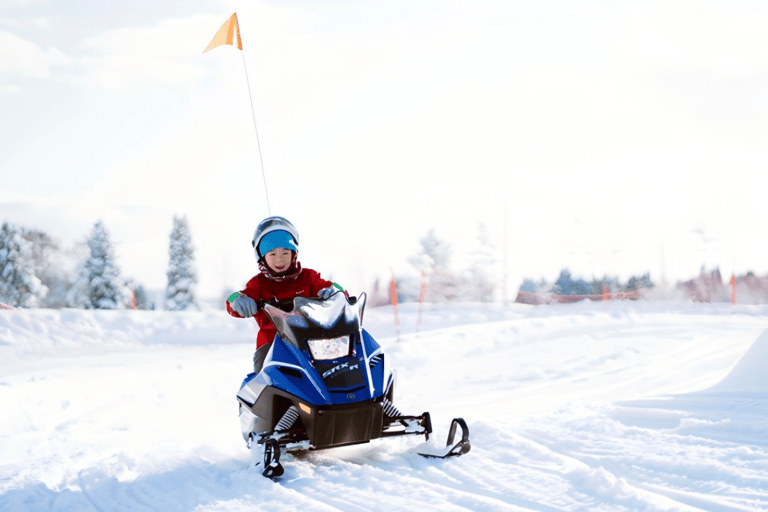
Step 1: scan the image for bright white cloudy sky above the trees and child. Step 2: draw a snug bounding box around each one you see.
[0,0,768,298]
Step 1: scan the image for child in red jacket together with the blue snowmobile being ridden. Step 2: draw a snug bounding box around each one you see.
[227,217,470,477]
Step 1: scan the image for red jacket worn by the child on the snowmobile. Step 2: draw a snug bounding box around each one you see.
[222,268,333,348]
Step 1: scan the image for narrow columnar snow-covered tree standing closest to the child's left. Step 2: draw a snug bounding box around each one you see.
[165,217,198,311]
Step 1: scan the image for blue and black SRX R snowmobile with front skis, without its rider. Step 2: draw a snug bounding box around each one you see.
[237,292,470,478]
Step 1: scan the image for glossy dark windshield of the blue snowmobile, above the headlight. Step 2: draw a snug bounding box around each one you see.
[264,292,366,349]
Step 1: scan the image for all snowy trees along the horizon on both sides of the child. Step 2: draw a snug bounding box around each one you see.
[9,216,756,311]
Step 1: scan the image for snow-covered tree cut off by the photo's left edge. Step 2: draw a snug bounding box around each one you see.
[0,222,48,308]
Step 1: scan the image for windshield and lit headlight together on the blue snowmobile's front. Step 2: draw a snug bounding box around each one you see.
[264,292,365,360]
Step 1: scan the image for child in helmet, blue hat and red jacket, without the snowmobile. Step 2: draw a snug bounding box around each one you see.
[227,216,342,373]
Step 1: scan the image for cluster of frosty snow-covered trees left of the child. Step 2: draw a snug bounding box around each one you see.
[0,217,198,311]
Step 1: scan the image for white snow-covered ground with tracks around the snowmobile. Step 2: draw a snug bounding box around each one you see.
[0,302,768,512]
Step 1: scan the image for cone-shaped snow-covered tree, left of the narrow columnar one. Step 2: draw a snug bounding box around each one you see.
[67,221,129,309]
